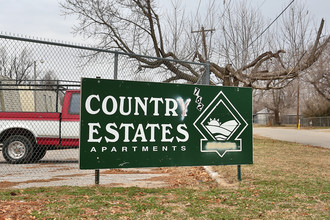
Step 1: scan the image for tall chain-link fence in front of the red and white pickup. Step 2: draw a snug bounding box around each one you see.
[0,35,209,179]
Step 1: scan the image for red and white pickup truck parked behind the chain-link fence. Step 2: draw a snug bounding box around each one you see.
[0,90,80,164]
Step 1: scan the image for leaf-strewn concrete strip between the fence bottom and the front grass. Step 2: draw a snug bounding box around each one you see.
[0,163,169,189]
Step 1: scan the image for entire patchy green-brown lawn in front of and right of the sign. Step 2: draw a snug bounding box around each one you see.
[0,138,330,219]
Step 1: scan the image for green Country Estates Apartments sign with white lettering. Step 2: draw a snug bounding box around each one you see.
[80,78,253,169]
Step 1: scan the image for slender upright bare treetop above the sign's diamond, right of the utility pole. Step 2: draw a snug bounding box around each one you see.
[217,1,265,74]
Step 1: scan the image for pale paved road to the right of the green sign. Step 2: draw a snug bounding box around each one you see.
[253,127,330,148]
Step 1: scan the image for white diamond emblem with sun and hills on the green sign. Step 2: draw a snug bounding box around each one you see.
[194,91,248,157]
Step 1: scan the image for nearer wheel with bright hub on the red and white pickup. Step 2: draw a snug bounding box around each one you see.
[2,135,33,164]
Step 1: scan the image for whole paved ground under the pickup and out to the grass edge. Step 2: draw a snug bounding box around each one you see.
[0,149,173,188]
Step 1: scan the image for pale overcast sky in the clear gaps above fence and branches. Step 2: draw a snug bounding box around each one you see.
[0,0,330,43]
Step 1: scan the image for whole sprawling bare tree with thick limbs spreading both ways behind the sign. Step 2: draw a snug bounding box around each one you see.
[61,0,330,89]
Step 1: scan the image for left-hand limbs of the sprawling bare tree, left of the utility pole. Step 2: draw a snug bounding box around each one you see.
[62,0,204,82]
